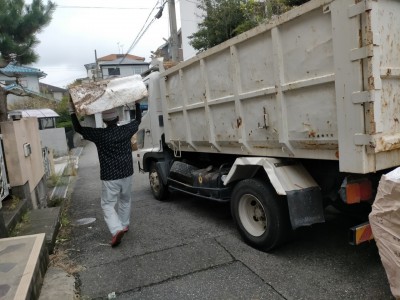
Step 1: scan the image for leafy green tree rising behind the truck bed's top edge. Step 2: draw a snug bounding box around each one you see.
[189,0,309,52]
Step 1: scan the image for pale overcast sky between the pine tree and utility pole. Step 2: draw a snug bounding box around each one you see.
[26,0,180,87]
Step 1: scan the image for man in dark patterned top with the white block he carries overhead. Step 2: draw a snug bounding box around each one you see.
[69,75,147,247]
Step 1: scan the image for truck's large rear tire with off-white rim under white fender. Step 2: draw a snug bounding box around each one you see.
[231,179,291,251]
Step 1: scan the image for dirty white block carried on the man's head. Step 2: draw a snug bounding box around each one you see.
[69,75,147,115]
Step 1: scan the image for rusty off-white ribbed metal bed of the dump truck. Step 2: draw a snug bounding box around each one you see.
[161,0,400,173]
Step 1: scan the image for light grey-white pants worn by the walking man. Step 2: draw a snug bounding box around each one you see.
[101,176,132,235]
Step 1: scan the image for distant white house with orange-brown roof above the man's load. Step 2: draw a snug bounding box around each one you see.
[85,54,149,81]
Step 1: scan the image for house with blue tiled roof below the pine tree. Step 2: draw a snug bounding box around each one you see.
[0,62,47,104]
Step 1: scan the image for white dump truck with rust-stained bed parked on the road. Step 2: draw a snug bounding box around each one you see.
[136,0,400,251]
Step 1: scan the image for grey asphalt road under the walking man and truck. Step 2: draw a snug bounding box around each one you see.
[68,143,393,300]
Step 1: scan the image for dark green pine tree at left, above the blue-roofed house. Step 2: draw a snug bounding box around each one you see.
[0,0,56,122]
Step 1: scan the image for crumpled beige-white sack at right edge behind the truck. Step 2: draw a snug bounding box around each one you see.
[369,168,400,299]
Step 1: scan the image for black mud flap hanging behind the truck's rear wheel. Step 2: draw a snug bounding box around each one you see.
[287,187,325,229]
